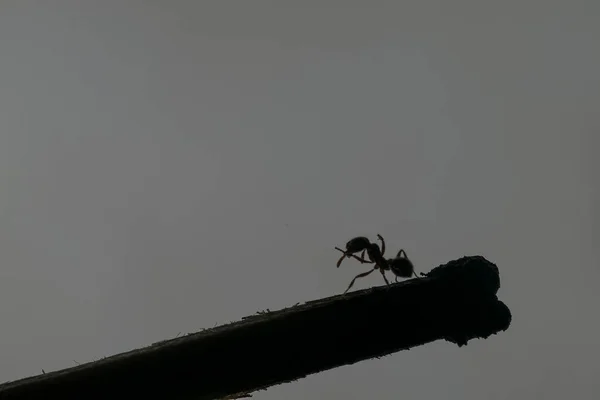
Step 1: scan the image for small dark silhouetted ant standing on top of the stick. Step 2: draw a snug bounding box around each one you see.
[335,234,418,294]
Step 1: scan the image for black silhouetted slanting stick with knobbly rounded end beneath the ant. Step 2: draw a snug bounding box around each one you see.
[0,256,511,400]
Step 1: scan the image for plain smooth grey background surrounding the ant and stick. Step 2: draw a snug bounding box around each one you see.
[0,0,600,400]
